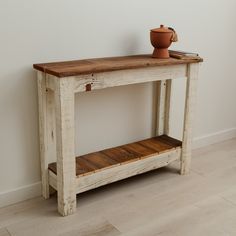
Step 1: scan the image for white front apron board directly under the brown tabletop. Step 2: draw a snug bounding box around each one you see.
[74,65,187,93]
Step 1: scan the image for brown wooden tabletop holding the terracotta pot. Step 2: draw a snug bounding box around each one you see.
[33,55,203,77]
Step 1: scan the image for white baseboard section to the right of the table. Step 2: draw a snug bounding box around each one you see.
[193,128,236,149]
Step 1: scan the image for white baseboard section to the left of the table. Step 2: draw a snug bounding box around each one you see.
[0,182,41,207]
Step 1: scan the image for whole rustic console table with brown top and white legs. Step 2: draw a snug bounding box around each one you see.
[34,55,202,216]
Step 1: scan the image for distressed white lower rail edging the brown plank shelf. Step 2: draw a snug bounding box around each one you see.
[49,147,181,194]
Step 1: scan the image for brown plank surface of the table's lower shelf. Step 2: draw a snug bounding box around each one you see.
[48,135,182,177]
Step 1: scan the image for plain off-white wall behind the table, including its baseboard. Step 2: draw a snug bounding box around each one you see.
[0,0,236,205]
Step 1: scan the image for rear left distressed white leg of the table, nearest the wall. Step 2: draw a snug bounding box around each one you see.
[37,72,56,199]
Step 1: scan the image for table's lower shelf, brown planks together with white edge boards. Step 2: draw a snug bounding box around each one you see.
[48,135,182,193]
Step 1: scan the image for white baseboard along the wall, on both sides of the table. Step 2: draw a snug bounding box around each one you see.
[0,128,236,207]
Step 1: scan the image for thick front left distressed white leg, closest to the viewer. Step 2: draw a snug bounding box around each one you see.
[55,78,76,216]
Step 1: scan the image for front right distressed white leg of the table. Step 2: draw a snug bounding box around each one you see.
[180,63,198,175]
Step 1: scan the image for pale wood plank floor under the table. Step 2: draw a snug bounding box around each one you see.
[0,139,236,236]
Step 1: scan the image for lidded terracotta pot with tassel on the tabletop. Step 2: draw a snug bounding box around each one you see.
[150,25,178,59]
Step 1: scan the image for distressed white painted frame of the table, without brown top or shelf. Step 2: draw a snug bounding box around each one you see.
[38,63,198,216]
